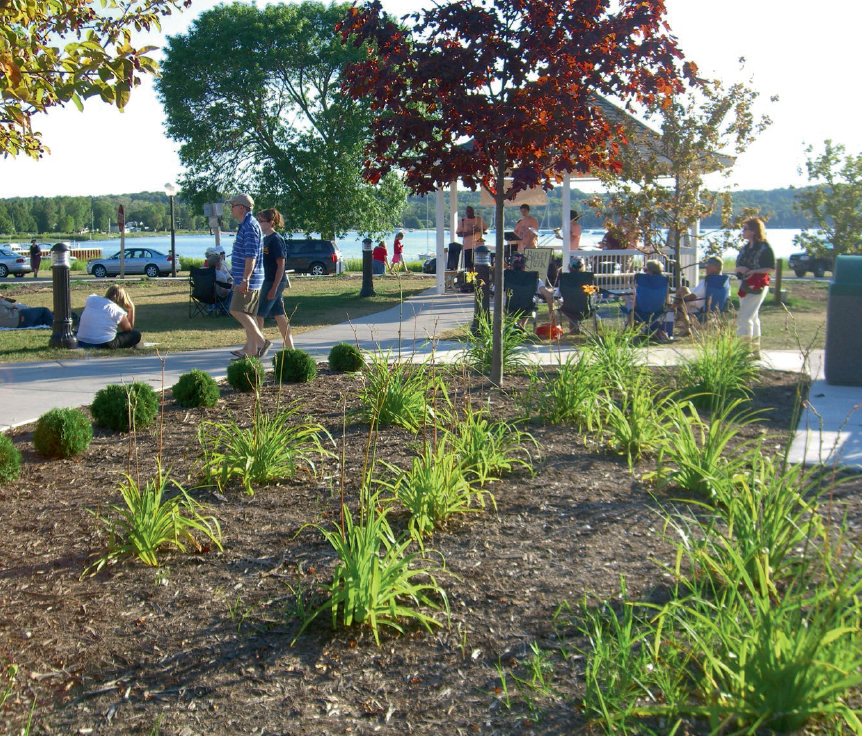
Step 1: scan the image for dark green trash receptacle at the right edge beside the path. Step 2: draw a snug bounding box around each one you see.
[824,256,862,386]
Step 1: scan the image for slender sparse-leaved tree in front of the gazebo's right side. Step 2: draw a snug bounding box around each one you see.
[591,70,775,286]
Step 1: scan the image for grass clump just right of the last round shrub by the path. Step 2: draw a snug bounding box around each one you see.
[357,353,449,432]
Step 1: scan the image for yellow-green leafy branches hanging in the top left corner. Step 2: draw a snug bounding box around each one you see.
[0,0,191,158]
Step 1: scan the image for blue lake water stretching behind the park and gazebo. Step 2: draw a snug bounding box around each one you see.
[81,228,801,268]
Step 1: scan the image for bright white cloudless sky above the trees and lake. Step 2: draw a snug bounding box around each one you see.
[0,0,862,198]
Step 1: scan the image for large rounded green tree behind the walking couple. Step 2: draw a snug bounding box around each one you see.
[157,2,405,236]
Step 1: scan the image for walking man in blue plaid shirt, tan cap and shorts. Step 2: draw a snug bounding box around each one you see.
[225,194,272,359]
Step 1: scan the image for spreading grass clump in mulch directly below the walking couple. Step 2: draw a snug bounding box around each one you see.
[198,405,334,496]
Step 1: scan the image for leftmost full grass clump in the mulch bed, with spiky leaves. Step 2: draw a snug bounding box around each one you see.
[84,465,222,575]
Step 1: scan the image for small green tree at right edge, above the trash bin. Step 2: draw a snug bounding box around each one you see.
[793,140,862,255]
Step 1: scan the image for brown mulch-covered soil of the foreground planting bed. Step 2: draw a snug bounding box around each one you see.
[0,369,858,736]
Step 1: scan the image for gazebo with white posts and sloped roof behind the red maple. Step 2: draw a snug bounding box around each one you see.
[428,94,734,294]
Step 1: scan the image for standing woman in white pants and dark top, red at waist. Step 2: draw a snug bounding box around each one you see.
[736,217,775,358]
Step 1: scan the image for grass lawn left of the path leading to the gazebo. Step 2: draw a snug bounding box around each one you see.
[0,275,434,363]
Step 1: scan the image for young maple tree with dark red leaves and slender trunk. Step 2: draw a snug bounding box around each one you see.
[338,0,696,385]
